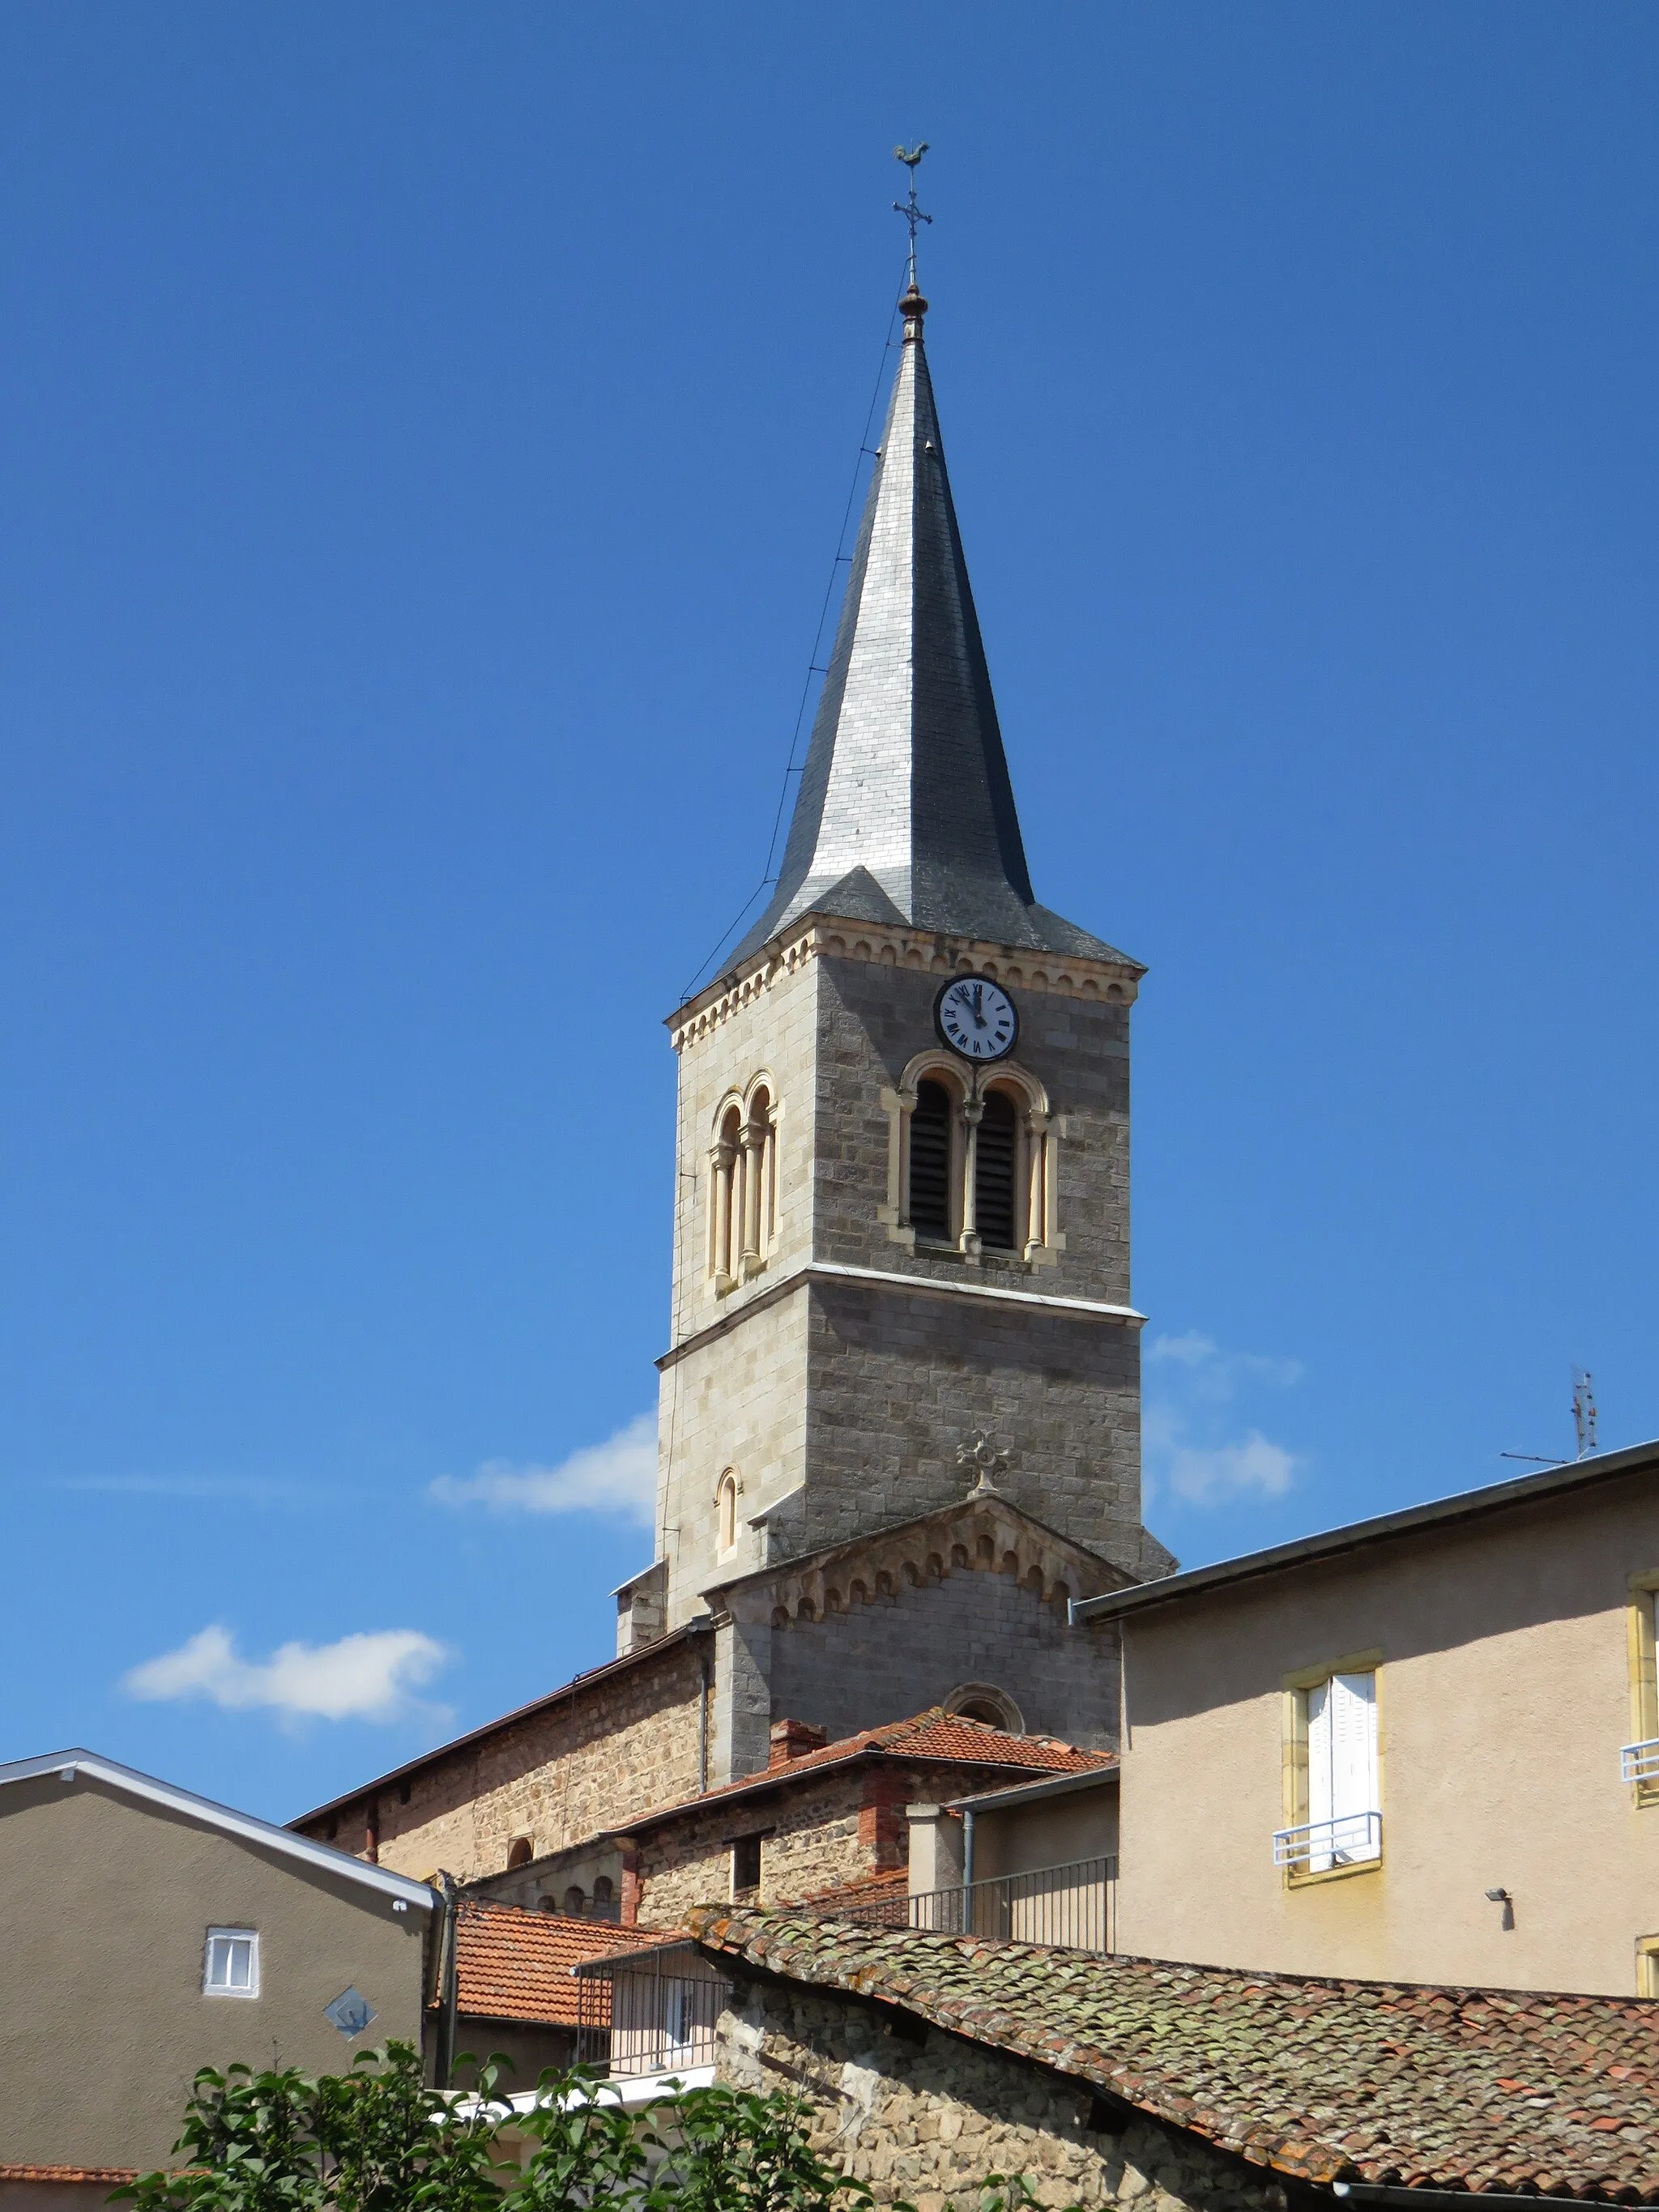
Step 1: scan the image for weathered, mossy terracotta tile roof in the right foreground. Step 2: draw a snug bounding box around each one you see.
[693,1909,1659,2203]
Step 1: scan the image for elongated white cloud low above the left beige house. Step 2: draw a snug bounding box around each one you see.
[122,1624,447,1721]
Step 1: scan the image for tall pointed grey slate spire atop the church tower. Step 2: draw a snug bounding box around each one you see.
[732,281,1124,960]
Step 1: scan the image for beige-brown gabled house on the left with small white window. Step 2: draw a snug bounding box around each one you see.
[0,1750,436,2208]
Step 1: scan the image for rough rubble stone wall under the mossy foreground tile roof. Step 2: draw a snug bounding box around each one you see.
[717,1980,1286,2212]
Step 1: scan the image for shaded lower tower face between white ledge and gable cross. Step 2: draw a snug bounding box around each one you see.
[803,1281,1144,1573]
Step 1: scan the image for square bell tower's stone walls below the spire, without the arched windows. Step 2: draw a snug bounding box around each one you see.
[657,925,1168,1624]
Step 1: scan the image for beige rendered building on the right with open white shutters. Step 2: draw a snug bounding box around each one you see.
[1073,1444,1659,1995]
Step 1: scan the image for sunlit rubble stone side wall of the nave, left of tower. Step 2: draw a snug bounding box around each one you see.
[294,1639,706,1882]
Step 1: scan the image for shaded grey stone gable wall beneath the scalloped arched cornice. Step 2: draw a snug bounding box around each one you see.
[772,1566,1117,1752]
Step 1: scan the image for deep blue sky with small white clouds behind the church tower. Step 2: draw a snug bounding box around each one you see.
[0,0,1659,1816]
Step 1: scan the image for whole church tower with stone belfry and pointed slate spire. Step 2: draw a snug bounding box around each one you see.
[621,285,1168,1672]
